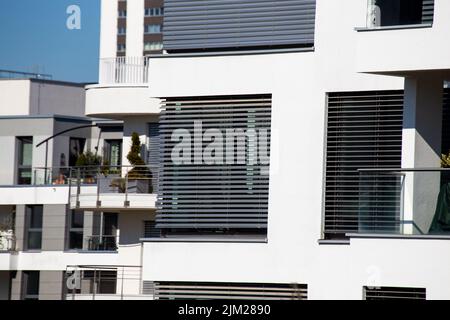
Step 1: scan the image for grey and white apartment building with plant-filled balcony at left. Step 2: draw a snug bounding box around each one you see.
[0,79,154,300]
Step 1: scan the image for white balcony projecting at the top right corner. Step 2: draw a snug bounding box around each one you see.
[355,0,450,76]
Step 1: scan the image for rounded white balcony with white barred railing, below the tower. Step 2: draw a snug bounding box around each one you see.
[86,57,159,119]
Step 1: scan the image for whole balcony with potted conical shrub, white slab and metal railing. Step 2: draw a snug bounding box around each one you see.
[69,166,158,211]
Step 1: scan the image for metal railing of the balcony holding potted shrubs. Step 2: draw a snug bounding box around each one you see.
[69,166,159,207]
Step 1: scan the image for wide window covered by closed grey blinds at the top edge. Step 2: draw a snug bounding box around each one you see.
[163,0,316,52]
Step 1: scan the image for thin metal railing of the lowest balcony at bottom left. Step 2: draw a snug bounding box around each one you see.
[64,265,149,300]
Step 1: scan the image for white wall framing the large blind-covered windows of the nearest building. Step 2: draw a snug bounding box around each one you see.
[143,0,450,299]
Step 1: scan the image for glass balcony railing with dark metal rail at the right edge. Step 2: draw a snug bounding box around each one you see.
[358,168,450,236]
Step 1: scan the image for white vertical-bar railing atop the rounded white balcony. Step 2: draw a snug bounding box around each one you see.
[100,57,148,84]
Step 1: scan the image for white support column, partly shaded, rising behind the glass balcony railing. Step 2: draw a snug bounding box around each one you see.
[402,75,443,234]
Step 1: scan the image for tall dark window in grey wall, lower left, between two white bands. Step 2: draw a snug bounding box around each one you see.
[25,205,44,250]
